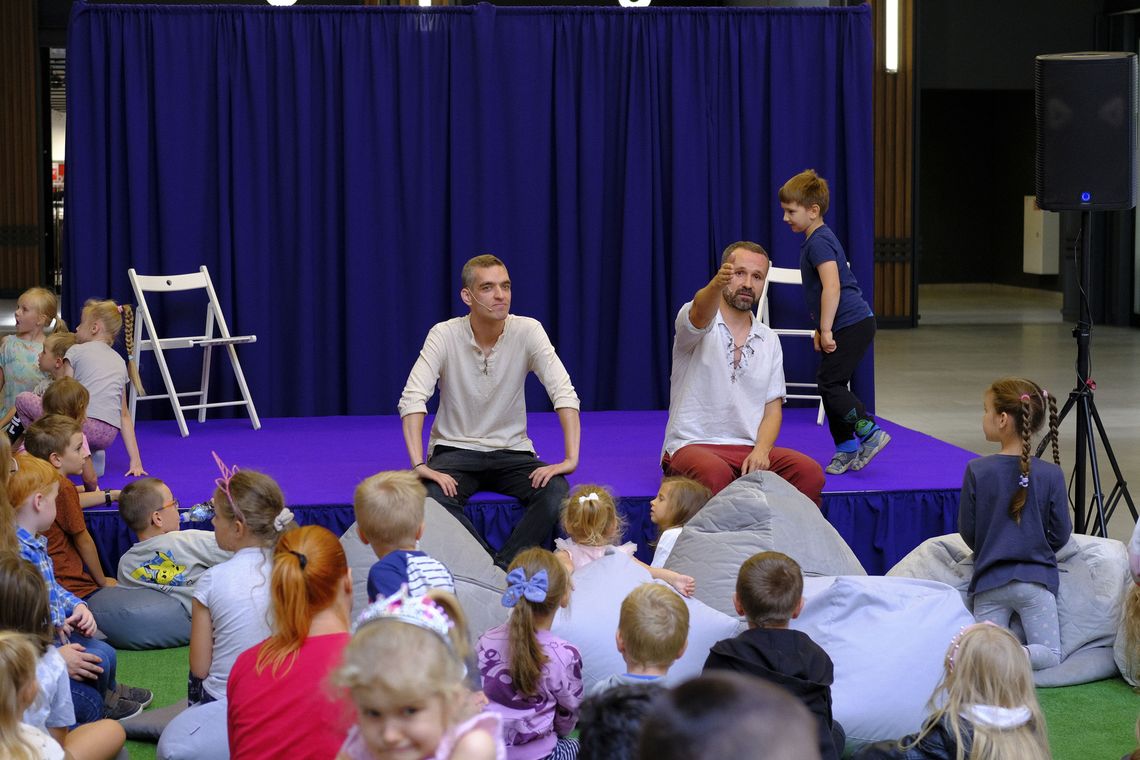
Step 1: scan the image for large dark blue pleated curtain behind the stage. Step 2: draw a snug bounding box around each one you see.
[64,0,873,416]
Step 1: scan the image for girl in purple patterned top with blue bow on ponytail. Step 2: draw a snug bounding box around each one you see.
[477,548,583,760]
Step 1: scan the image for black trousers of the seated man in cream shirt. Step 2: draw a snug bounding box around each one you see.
[424,446,570,567]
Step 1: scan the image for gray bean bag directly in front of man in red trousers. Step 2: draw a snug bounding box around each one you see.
[665,472,866,615]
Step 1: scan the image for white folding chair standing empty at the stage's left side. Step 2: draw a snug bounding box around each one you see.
[127,267,261,438]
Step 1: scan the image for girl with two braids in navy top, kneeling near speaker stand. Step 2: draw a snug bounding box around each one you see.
[958,377,1073,670]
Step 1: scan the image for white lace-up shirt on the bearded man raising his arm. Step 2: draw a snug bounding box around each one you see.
[662,301,787,456]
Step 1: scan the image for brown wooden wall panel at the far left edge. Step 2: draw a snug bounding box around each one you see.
[0,0,41,291]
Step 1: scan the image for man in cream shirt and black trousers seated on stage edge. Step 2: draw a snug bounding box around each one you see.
[399,255,581,567]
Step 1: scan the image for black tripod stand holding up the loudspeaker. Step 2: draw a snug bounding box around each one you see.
[1036,211,1137,538]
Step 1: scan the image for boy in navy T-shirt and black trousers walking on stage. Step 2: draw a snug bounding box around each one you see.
[780,169,890,475]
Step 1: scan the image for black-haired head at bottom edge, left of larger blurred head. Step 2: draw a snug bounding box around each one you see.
[578,683,663,760]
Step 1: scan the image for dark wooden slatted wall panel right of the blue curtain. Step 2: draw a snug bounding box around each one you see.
[871,0,918,326]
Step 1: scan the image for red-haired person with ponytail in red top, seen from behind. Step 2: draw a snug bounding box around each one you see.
[227,525,352,759]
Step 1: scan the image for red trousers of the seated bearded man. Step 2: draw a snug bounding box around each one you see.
[661,443,824,507]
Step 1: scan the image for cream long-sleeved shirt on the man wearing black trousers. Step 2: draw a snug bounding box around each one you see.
[399,314,579,457]
